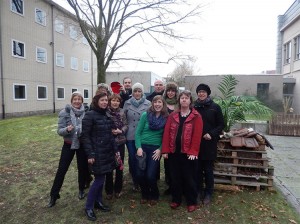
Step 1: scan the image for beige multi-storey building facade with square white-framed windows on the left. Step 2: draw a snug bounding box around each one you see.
[0,0,97,119]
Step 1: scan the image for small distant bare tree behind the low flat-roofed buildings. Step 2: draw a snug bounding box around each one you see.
[168,57,196,86]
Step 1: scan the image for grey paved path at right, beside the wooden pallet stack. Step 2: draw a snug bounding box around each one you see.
[265,135,300,214]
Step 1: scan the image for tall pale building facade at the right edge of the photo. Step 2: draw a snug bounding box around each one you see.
[276,0,300,114]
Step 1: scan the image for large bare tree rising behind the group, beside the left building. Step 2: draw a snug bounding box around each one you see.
[67,0,201,83]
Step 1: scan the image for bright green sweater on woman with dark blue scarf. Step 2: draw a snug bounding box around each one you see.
[135,112,164,149]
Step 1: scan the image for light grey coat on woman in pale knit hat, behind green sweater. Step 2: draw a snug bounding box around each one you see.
[123,99,151,141]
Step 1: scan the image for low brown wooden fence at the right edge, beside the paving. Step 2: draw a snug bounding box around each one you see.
[269,113,300,136]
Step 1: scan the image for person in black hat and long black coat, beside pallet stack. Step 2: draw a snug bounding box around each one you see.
[194,83,224,205]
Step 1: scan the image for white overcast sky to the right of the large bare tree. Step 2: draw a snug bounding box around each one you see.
[56,0,294,76]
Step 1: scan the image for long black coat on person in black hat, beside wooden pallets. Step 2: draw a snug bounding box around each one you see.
[194,100,224,160]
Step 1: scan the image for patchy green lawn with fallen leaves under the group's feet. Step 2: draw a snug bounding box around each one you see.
[0,115,300,224]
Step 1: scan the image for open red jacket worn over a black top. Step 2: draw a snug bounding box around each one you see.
[161,109,203,156]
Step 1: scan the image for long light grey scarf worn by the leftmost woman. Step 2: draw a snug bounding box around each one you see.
[66,104,85,149]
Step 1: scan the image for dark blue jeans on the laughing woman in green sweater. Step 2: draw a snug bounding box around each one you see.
[135,144,160,200]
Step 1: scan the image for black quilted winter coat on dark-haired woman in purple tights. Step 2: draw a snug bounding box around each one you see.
[81,108,117,175]
